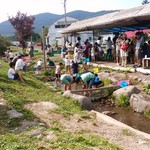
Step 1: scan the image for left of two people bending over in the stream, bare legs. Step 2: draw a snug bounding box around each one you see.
[60,74,73,91]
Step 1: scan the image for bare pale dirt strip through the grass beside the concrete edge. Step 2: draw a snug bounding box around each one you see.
[25,102,150,150]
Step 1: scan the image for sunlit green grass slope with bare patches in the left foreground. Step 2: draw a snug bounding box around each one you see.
[0,48,118,150]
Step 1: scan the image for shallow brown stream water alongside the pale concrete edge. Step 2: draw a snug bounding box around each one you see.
[93,102,150,134]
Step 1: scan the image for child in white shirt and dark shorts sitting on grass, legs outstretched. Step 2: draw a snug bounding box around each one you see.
[8,62,24,82]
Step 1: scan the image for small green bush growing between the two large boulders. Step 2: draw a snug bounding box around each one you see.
[115,94,130,107]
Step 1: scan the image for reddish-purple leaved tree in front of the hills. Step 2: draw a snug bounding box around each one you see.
[8,11,35,53]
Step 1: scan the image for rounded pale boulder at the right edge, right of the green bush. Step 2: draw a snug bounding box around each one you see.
[130,94,150,113]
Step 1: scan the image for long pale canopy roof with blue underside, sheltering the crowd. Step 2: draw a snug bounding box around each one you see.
[62,4,150,34]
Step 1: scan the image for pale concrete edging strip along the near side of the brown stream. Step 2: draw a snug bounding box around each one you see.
[91,110,150,139]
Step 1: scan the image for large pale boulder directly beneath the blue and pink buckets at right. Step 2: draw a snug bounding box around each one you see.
[113,86,140,99]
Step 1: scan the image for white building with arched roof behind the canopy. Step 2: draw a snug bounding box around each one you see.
[46,17,93,46]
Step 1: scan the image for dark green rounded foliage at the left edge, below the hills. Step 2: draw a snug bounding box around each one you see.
[0,35,10,54]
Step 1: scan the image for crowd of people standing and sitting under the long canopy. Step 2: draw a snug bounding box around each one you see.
[62,32,150,67]
